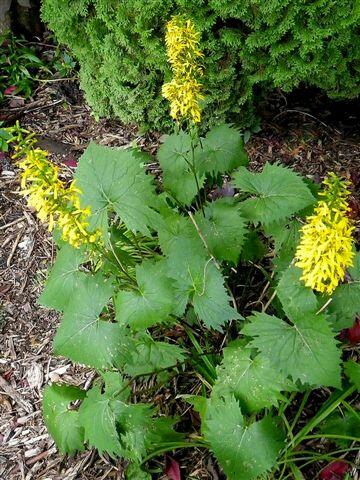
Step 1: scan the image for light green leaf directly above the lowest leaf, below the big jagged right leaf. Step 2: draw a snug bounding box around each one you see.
[212,344,291,413]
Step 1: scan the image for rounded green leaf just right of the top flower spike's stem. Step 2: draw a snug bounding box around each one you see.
[197,125,249,174]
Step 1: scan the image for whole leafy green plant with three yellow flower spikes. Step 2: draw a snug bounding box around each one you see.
[12,16,360,480]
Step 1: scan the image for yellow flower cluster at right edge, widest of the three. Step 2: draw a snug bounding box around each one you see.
[295,173,354,295]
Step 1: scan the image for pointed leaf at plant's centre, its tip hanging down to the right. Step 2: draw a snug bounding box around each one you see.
[168,255,241,330]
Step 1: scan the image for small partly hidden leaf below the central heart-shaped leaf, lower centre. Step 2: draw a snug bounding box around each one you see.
[124,335,185,376]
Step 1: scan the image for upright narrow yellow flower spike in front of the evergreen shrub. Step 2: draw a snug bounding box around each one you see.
[162,15,204,123]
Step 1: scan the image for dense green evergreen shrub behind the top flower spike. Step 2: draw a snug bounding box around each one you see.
[42,0,360,129]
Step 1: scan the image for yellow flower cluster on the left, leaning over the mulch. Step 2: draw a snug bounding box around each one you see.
[14,127,101,248]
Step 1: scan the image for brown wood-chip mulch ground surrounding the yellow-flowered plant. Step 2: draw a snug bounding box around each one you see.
[0,76,360,480]
